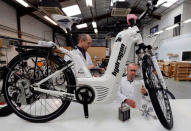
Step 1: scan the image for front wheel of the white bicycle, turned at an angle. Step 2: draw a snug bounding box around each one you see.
[142,55,173,130]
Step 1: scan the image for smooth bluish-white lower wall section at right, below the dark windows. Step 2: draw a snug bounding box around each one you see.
[157,33,191,61]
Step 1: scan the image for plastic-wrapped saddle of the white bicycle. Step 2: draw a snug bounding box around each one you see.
[52,14,81,30]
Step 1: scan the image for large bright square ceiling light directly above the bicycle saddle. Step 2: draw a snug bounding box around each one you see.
[62,5,81,16]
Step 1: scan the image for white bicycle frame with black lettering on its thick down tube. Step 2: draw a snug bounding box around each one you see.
[33,26,166,103]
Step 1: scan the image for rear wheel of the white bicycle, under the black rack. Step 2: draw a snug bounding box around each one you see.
[3,50,76,122]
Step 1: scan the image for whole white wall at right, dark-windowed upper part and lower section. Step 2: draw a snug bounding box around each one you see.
[143,2,191,61]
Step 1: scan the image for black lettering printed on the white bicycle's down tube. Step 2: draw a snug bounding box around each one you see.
[112,43,127,76]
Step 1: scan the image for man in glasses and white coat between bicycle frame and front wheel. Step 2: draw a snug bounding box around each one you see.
[117,63,147,108]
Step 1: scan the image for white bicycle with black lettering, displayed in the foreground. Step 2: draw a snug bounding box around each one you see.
[3,0,173,129]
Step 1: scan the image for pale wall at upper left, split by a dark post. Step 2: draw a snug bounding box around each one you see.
[0,1,52,41]
